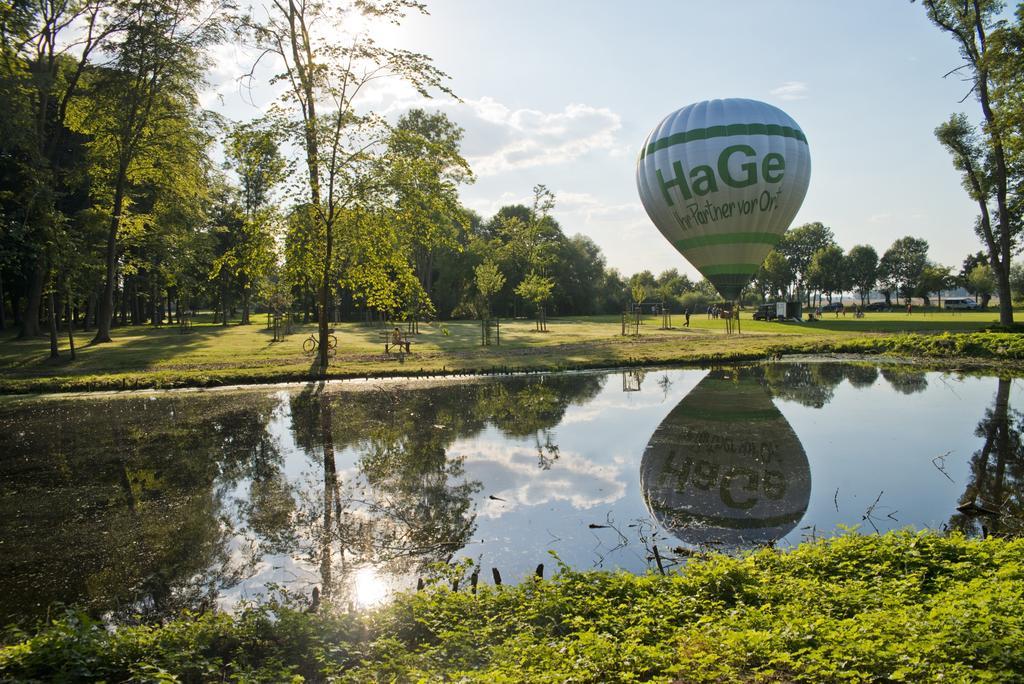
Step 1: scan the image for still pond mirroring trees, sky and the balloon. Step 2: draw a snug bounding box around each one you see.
[0,361,1024,624]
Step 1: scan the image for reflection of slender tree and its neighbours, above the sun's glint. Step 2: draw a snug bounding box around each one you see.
[291,375,603,601]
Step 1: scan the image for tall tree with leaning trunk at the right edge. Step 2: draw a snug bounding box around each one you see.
[922,0,1024,326]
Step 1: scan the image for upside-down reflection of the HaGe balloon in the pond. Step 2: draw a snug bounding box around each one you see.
[640,371,811,547]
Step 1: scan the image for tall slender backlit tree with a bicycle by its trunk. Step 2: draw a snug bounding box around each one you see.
[249,0,451,371]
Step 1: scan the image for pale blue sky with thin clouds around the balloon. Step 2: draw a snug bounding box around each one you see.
[209,0,981,277]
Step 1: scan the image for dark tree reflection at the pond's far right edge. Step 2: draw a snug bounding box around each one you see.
[950,378,1024,536]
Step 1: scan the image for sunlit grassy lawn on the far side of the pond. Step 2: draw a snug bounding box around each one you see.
[0,312,1024,393]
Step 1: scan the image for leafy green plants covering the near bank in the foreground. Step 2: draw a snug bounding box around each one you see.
[0,532,1024,682]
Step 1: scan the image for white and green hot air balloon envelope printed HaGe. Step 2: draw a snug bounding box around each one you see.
[637,98,811,301]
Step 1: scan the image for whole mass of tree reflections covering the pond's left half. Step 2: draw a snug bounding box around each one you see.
[0,374,604,622]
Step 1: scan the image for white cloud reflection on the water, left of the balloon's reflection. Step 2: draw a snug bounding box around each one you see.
[460,441,626,518]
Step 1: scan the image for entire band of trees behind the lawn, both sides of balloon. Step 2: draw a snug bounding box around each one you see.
[0,0,1024,365]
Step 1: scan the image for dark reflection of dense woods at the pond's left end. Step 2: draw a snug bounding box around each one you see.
[0,394,280,617]
